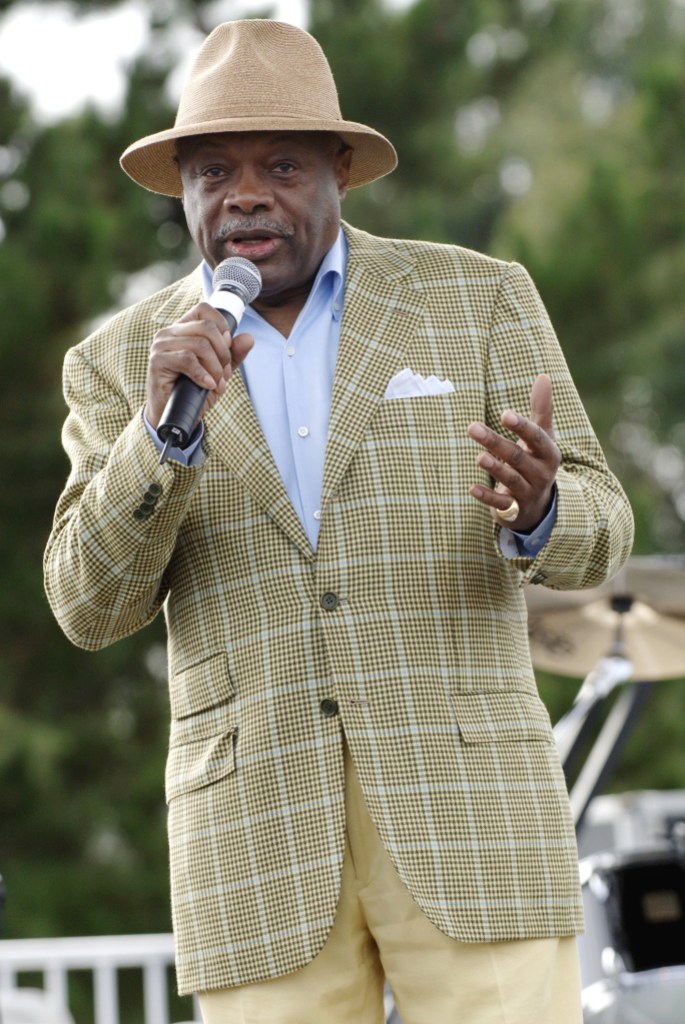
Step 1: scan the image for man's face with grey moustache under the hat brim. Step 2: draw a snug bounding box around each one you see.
[178,132,351,306]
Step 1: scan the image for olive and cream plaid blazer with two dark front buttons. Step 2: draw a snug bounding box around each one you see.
[45,226,632,992]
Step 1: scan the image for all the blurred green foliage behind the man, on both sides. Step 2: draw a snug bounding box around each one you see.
[0,0,685,970]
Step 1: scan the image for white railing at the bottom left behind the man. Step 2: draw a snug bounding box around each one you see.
[0,935,202,1024]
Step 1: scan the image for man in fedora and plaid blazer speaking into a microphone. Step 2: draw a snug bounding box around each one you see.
[46,20,632,1024]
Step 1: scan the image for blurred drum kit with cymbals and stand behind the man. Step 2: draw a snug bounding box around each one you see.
[526,556,685,1024]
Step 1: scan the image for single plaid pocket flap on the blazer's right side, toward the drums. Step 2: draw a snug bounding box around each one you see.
[452,692,554,743]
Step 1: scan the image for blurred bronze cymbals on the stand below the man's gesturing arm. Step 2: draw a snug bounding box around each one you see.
[526,555,685,682]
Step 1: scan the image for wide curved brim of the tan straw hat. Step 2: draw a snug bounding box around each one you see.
[121,118,397,197]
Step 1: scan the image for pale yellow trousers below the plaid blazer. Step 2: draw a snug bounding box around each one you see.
[200,752,583,1024]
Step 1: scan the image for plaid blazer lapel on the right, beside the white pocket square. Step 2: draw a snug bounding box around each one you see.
[322,225,424,506]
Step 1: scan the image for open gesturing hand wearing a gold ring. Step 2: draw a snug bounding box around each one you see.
[468,374,561,530]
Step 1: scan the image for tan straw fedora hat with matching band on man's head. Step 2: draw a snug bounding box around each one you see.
[121,18,397,196]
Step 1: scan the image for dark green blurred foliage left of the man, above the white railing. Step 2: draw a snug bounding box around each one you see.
[0,12,187,950]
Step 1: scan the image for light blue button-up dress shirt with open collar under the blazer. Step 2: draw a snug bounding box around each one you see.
[147,231,556,558]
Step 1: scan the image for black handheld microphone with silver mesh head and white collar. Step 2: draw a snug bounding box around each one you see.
[157,256,262,463]
